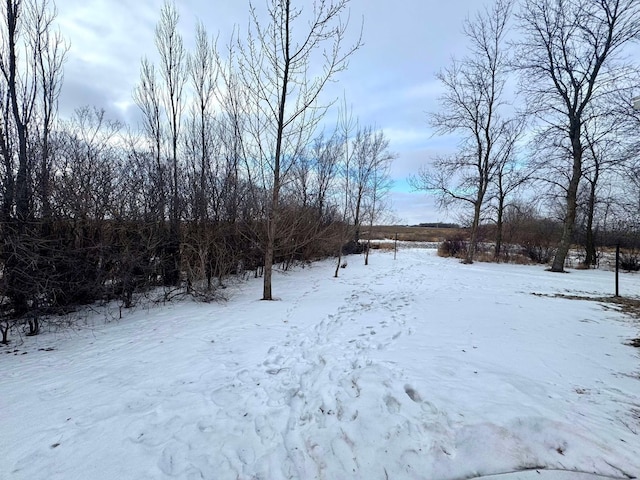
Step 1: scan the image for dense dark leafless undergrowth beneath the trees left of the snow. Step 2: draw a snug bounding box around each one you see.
[0,211,339,342]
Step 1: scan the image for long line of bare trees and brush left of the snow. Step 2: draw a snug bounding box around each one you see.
[0,0,394,343]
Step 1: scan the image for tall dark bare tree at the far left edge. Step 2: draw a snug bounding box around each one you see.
[0,0,66,335]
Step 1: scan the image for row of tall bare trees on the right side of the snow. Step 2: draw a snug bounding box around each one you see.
[411,0,640,272]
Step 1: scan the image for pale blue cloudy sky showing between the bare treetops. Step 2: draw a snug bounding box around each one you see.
[57,0,496,224]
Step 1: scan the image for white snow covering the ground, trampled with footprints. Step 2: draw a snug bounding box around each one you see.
[0,249,640,480]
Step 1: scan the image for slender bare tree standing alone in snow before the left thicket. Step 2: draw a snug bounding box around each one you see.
[240,0,360,300]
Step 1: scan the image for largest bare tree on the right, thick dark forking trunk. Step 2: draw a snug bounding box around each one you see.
[517,0,640,272]
